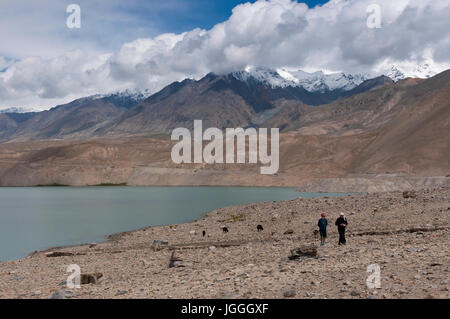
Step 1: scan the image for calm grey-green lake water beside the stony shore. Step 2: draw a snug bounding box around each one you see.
[0,187,348,261]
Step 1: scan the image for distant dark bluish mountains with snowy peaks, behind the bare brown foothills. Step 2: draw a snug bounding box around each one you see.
[0,67,393,142]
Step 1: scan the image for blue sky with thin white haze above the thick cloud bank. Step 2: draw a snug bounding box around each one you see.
[0,0,327,59]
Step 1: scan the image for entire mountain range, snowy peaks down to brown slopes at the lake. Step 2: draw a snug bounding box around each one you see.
[0,69,450,191]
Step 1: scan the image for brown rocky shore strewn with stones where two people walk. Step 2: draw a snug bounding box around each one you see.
[0,187,450,299]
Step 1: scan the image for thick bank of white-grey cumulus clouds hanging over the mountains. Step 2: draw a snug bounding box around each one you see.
[0,0,450,108]
